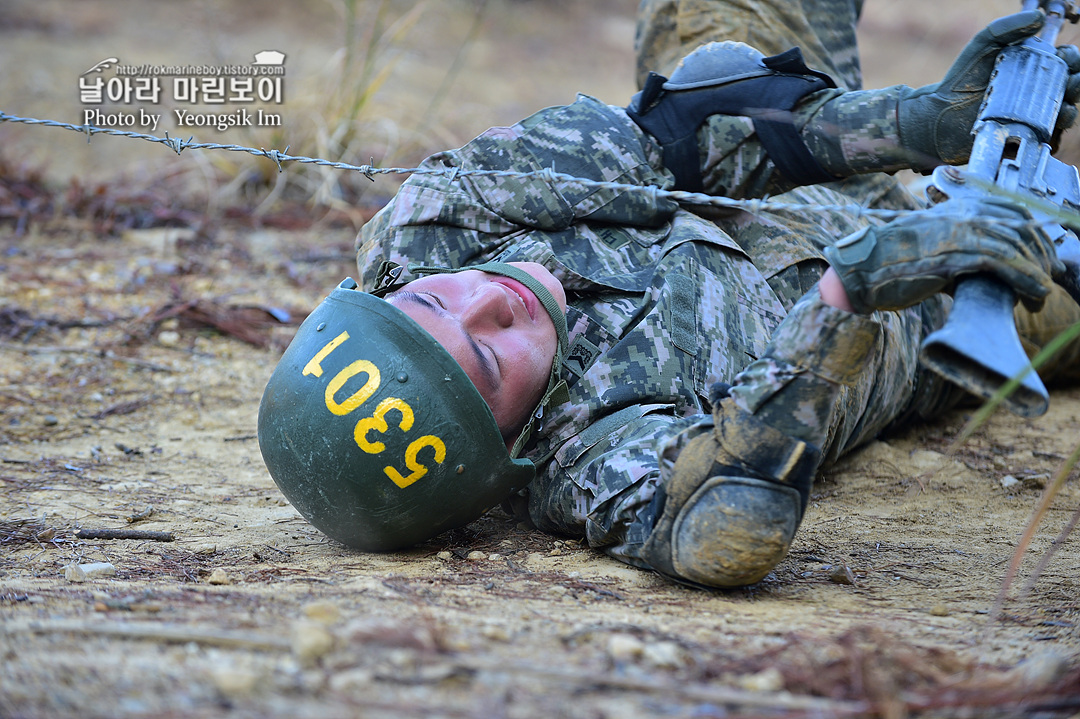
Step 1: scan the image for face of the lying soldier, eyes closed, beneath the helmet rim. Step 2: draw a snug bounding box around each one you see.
[386,262,566,445]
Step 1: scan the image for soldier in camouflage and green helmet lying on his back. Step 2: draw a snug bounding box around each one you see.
[259,0,1080,586]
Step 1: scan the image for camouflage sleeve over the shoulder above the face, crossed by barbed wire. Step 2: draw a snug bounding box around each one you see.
[356,96,676,286]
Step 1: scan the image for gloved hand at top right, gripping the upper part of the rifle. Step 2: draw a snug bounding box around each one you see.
[899,10,1080,171]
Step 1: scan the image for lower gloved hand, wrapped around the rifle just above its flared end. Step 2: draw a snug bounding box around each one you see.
[825,199,1065,313]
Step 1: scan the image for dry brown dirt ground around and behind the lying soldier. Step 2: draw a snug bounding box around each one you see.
[0,0,1080,719]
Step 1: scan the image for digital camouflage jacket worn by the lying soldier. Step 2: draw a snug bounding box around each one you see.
[357,96,928,564]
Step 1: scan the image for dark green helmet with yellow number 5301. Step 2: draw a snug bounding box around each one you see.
[258,268,565,552]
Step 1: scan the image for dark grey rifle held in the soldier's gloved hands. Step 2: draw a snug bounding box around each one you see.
[920,0,1080,417]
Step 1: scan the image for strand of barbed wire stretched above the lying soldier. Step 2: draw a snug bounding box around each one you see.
[0,111,909,220]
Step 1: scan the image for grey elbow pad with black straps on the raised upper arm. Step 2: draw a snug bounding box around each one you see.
[626,42,838,192]
